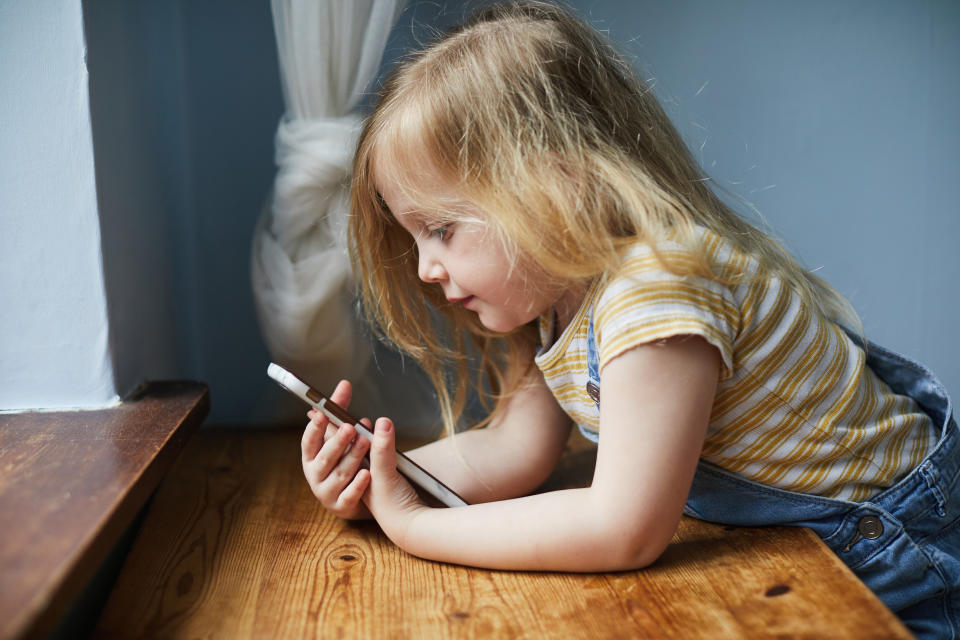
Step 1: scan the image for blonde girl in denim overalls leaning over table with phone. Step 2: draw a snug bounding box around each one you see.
[302,2,960,637]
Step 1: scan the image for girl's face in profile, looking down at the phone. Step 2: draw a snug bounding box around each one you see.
[377,170,565,332]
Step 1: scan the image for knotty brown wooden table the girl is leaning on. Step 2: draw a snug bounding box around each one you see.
[95,428,910,640]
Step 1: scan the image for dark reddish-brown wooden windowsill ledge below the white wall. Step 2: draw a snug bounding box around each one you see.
[0,382,208,638]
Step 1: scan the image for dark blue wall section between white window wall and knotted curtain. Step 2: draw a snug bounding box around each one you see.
[84,0,283,423]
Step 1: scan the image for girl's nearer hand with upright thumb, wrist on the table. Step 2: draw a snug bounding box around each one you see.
[363,418,429,548]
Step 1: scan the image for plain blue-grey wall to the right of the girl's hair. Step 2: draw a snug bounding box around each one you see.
[577,0,960,396]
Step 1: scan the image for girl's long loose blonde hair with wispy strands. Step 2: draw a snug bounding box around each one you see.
[350,2,855,436]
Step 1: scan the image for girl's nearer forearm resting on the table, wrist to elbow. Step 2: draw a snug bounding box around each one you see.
[390,488,679,571]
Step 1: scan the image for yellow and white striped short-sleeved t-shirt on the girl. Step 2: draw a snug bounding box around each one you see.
[536,231,938,501]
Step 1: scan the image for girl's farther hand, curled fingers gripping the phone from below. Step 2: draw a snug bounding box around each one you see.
[300,380,370,519]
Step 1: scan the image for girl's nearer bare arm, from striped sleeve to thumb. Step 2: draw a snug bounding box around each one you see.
[364,337,720,571]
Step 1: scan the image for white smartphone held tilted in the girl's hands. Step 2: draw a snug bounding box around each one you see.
[267,362,467,507]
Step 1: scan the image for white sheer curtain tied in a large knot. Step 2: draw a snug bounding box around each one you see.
[252,0,405,420]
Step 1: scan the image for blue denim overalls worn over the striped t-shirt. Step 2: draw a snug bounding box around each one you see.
[581,316,960,639]
